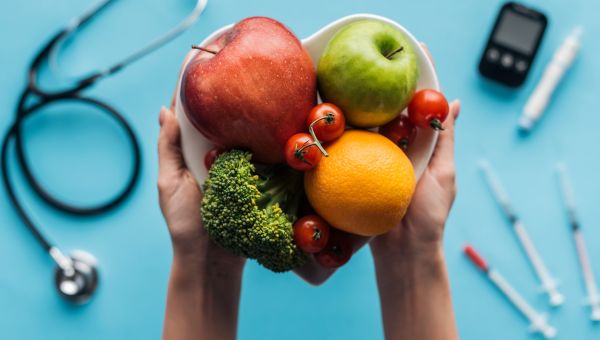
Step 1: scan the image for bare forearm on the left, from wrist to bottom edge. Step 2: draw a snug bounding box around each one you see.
[163,255,242,340]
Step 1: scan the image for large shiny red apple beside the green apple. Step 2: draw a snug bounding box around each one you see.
[182,17,317,163]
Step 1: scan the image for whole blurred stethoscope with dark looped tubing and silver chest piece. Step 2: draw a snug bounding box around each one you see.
[1,0,207,303]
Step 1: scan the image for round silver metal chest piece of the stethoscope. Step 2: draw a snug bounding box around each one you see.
[54,250,98,304]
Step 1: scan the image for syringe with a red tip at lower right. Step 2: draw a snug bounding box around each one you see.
[464,245,556,339]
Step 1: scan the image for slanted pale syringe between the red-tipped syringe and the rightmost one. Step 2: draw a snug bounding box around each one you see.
[480,160,565,306]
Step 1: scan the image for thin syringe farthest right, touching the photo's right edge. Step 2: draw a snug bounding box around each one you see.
[556,164,600,321]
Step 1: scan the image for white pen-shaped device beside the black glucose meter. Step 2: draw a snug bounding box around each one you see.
[519,26,583,132]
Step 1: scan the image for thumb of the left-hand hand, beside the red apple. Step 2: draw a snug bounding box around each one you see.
[158,107,185,178]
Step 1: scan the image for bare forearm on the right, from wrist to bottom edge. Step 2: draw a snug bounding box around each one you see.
[375,248,458,340]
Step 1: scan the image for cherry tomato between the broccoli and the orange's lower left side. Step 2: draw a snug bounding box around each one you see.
[294,215,329,253]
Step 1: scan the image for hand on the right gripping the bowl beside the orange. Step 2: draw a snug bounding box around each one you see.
[370,101,460,265]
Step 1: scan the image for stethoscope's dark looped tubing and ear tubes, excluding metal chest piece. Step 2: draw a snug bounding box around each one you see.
[0,0,207,260]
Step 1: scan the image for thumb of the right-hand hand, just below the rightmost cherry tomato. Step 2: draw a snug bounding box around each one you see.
[429,100,460,177]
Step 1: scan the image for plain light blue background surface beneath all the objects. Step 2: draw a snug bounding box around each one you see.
[0,0,600,339]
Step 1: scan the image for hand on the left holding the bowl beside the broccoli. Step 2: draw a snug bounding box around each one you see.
[158,108,244,273]
